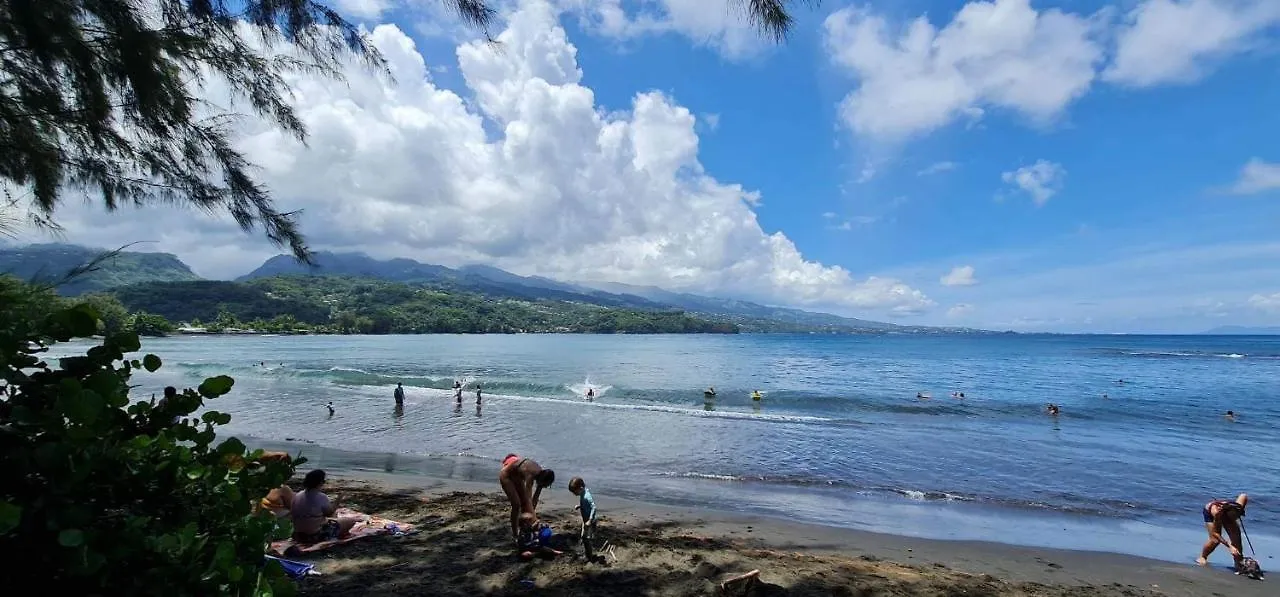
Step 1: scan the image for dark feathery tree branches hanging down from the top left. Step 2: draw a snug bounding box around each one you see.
[0,0,817,259]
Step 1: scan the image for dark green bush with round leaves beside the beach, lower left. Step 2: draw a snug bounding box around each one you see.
[0,288,301,596]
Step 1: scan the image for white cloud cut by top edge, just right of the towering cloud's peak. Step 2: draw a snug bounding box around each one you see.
[557,0,769,60]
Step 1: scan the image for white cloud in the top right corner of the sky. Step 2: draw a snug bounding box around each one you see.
[1103,0,1280,87]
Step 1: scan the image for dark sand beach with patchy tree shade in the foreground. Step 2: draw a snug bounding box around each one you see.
[300,473,1275,597]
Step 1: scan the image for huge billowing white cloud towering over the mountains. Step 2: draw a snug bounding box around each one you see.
[40,0,933,314]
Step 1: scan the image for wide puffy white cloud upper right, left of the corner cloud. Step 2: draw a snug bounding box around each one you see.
[824,0,1103,141]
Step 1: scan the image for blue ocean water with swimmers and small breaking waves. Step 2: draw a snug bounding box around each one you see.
[54,334,1280,561]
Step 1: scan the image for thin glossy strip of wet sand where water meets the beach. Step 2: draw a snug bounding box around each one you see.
[241,436,1275,569]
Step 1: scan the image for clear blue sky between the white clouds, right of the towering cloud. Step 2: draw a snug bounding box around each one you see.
[384,0,1280,331]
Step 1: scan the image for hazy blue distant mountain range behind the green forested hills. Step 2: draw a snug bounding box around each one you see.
[0,245,982,333]
